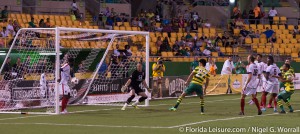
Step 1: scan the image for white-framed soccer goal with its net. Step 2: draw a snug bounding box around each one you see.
[0,27,150,114]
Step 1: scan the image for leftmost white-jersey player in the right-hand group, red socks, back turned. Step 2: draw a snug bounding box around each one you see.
[240,55,262,115]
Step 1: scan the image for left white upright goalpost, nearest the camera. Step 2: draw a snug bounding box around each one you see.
[55,28,60,114]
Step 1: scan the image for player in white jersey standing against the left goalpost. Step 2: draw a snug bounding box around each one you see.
[58,58,74,114]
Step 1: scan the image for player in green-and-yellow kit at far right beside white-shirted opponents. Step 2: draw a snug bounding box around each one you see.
[277,64,295,114]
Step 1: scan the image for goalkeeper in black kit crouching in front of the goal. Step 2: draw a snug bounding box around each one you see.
[121,63,151,110]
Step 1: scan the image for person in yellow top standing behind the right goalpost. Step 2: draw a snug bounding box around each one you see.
[152,57,166,98]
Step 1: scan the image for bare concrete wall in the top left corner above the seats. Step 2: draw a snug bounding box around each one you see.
[0,0,22,13]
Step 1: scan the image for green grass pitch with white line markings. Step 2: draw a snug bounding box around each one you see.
[0,91,300,134]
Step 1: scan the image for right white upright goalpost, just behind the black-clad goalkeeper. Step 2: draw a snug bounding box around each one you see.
[145,34,151,106]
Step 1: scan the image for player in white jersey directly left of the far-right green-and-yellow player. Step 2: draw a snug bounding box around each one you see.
[261,56,281,112]
